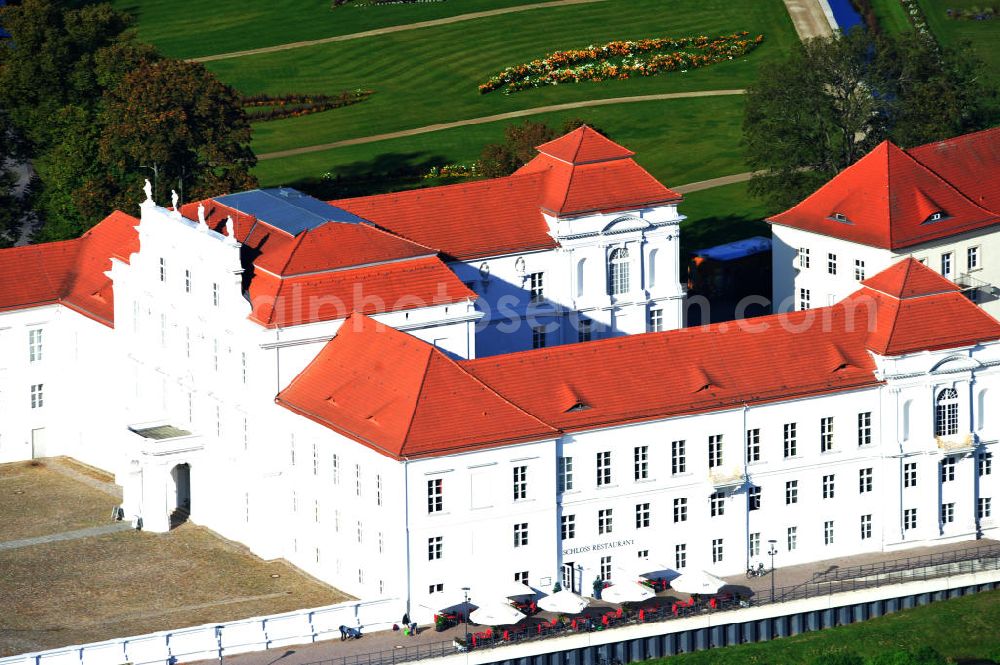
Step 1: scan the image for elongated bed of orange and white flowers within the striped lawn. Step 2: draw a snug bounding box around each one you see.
[479,31,764,95]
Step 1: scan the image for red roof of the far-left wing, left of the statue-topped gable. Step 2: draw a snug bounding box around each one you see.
[0,211,139,327]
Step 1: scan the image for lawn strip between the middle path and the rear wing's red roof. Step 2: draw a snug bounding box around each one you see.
[256,96,747,199]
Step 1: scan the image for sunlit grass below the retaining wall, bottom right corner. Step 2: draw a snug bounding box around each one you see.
[649,591,1000,665]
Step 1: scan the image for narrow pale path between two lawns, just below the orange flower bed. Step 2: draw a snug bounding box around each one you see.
[257,90,746,161]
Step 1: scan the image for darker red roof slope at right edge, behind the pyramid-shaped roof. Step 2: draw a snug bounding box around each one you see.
[907,127,1000,214]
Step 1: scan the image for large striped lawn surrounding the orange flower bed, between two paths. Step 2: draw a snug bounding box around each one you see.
[201,0,796,154]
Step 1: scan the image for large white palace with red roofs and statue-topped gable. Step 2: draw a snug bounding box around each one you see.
[0,128,1000,616]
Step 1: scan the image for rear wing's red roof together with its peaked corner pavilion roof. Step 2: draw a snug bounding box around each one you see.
[329,126,681,260]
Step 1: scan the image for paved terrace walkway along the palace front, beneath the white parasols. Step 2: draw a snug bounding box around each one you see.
[186,540,1000,665]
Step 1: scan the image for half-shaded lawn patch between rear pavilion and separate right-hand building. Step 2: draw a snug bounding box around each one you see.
[679,182,771,258]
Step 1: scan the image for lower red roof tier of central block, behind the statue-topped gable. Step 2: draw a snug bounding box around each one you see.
[248,257,476,328]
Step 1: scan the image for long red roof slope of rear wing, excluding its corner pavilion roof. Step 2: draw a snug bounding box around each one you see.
[330,174,556,260]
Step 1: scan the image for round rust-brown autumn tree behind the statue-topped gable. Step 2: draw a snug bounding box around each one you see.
[99,60,257,206]
